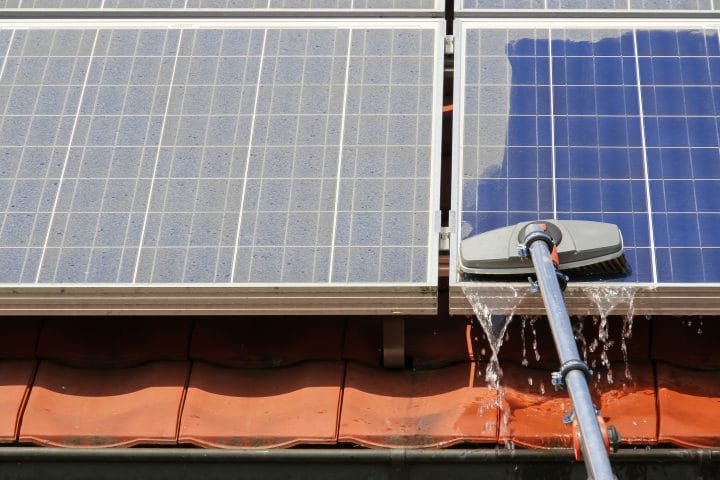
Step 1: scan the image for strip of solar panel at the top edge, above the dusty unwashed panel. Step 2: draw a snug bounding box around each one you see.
[0,0,444,12]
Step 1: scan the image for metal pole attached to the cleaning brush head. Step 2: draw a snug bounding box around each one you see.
[528,232,615,480]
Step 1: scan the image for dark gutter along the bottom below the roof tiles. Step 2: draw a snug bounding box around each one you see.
[0,447,720,480]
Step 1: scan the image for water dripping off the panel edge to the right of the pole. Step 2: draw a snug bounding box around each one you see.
[576,286,636,385]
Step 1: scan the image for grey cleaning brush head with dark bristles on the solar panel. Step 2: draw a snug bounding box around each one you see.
[460,220,629,276]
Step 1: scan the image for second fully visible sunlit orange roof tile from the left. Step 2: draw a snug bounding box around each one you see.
[179,362,345,448]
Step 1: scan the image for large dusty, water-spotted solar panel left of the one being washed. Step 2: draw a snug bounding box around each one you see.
[0,20,443,300]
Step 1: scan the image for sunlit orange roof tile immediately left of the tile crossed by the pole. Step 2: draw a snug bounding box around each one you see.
[339,363,497,447]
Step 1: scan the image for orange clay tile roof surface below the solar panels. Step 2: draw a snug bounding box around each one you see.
[0,317,720,448]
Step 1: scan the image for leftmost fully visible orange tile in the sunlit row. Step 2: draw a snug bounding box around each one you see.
[20,362,189,447]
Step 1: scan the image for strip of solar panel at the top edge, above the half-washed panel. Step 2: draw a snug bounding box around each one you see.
[456,0,720,12]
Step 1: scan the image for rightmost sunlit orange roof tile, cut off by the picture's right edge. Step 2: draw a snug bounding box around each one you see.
[657,363,720,448]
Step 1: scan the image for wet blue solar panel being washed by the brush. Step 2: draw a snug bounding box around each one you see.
[459,28,720,283]
